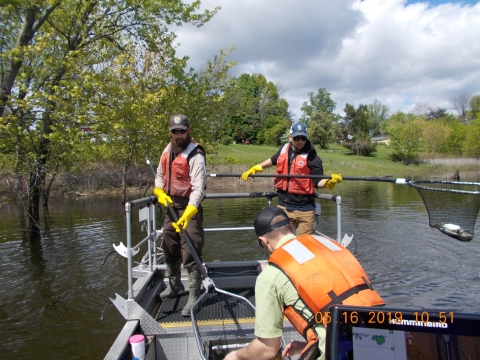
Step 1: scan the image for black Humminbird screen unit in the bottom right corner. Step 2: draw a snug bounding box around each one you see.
[326,306,480,360]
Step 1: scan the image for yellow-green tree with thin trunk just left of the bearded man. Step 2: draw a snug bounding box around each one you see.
[86,51,178,202]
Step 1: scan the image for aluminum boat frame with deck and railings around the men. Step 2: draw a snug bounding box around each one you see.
[105,192,346,360]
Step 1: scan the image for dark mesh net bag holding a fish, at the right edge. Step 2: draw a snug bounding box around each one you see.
[408,180,480,241]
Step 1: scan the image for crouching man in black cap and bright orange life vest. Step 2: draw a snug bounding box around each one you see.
[225,207,384,360]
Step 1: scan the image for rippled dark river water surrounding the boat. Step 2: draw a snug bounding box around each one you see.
[0,172,480,359]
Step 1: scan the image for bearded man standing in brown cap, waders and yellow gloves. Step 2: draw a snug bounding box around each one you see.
[153,114,206,316]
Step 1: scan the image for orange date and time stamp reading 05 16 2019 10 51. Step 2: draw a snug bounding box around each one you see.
[315,311,454,325]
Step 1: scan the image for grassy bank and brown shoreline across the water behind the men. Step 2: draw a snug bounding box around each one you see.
[0,144,480,204]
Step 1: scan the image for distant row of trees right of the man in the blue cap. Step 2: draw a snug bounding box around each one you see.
[301,89,480,164]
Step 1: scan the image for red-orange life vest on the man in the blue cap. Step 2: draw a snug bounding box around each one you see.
[273,144,315,195]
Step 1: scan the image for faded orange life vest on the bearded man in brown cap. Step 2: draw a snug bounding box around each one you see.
[160,141,198,197]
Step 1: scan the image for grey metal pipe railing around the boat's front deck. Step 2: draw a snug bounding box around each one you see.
[122,192,342,300]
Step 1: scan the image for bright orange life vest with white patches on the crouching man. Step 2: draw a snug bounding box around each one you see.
[268,235,385,358]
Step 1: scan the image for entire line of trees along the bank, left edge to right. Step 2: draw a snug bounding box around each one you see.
[0,0,479,230]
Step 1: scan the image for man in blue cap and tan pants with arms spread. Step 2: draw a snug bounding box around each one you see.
[242,123,342,235]
